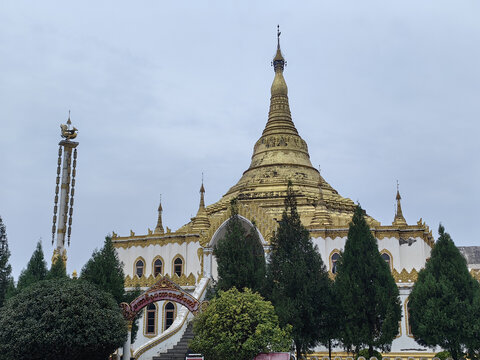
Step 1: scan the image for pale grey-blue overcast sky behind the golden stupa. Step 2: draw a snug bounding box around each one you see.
[0,0,480,277]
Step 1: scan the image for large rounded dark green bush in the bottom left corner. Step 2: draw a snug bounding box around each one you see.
[0,278,127,360]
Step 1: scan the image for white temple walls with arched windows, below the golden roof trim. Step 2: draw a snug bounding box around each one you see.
[117,228,431,358]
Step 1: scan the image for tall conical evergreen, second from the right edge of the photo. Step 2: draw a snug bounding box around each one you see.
[335,205,402,357]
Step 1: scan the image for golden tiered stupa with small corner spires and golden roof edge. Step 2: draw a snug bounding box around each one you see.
[113,30,433,264]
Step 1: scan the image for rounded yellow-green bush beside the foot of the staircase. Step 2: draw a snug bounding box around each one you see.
[189,288,291,360]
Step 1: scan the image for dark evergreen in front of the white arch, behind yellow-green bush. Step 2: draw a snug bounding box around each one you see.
[213,200,265,292]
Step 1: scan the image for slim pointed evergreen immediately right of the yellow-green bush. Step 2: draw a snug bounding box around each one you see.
[266,182,329,359]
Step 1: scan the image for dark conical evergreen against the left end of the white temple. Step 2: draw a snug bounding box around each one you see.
[80,236,125,303]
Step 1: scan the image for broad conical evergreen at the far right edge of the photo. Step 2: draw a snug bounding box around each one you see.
[408,225,480,360]
